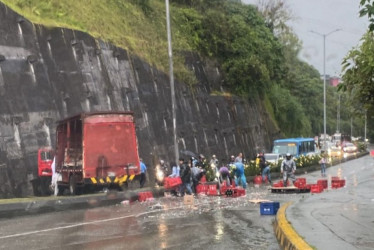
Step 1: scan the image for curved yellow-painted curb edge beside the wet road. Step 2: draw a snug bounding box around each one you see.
[274,202,313,250]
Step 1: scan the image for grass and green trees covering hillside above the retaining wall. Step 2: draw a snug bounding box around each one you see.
[0,0,366,139]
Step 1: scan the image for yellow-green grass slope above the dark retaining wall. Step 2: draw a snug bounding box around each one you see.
[0,0,199,84]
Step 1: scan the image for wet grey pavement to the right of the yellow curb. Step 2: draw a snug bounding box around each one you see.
[286,155,374,250]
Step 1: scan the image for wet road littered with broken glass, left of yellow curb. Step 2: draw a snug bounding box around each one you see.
[0,186,302,249]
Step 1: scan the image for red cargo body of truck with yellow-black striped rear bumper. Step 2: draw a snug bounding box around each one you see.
[56,112,140,195]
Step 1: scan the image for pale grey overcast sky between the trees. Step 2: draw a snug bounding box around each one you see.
[242,0,368,76]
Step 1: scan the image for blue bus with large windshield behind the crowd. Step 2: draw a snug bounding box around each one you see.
[272,138,316,157]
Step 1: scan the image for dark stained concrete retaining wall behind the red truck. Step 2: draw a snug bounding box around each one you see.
[0,3,278,198]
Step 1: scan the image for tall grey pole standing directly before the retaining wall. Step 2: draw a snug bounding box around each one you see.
[165,0,179,164]
